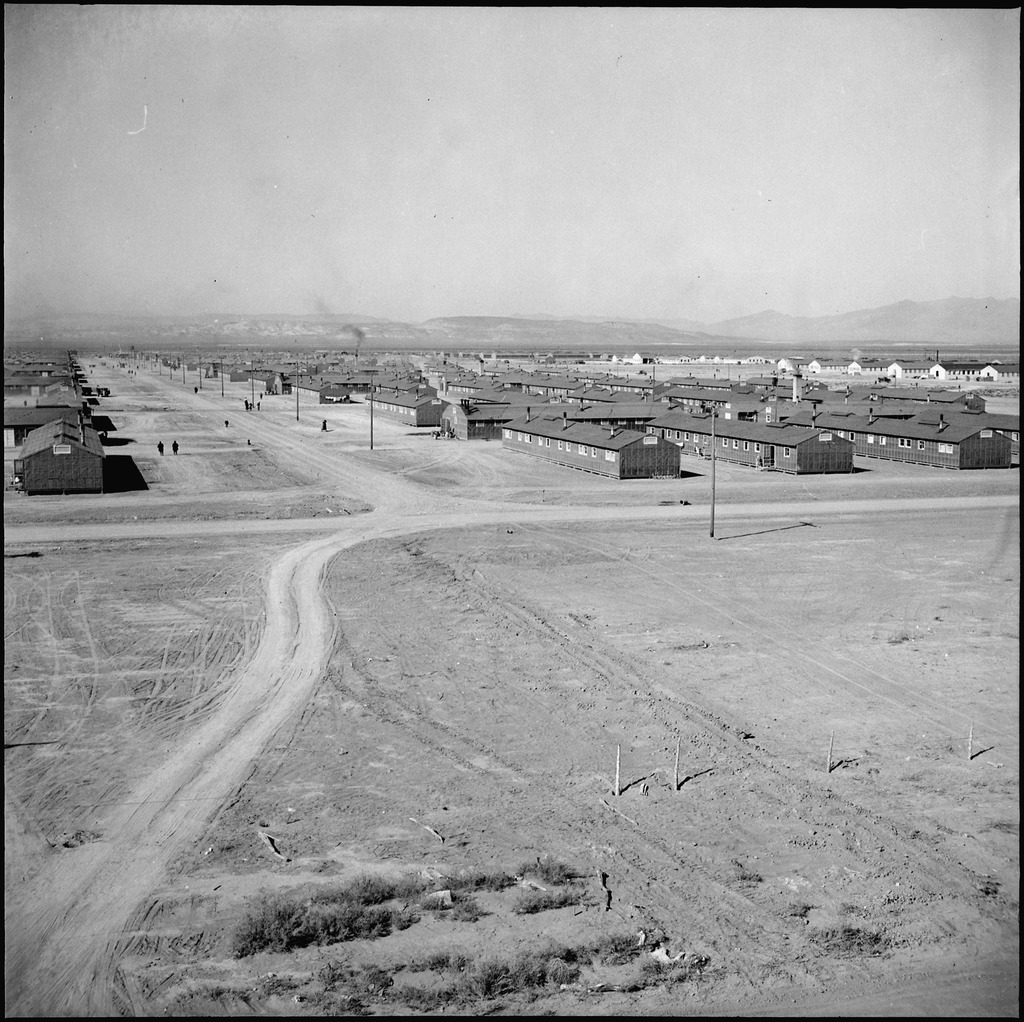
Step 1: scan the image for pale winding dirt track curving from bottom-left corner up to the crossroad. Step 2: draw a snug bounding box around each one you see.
[6,536,358,1016]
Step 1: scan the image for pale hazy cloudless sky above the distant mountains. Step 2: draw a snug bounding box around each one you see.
[4,4,1020,323]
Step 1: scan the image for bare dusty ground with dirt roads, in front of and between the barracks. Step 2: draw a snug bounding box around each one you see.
[4,366,1020,1016]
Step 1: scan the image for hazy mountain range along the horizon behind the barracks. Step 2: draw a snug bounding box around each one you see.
[5,298,1020,353]
